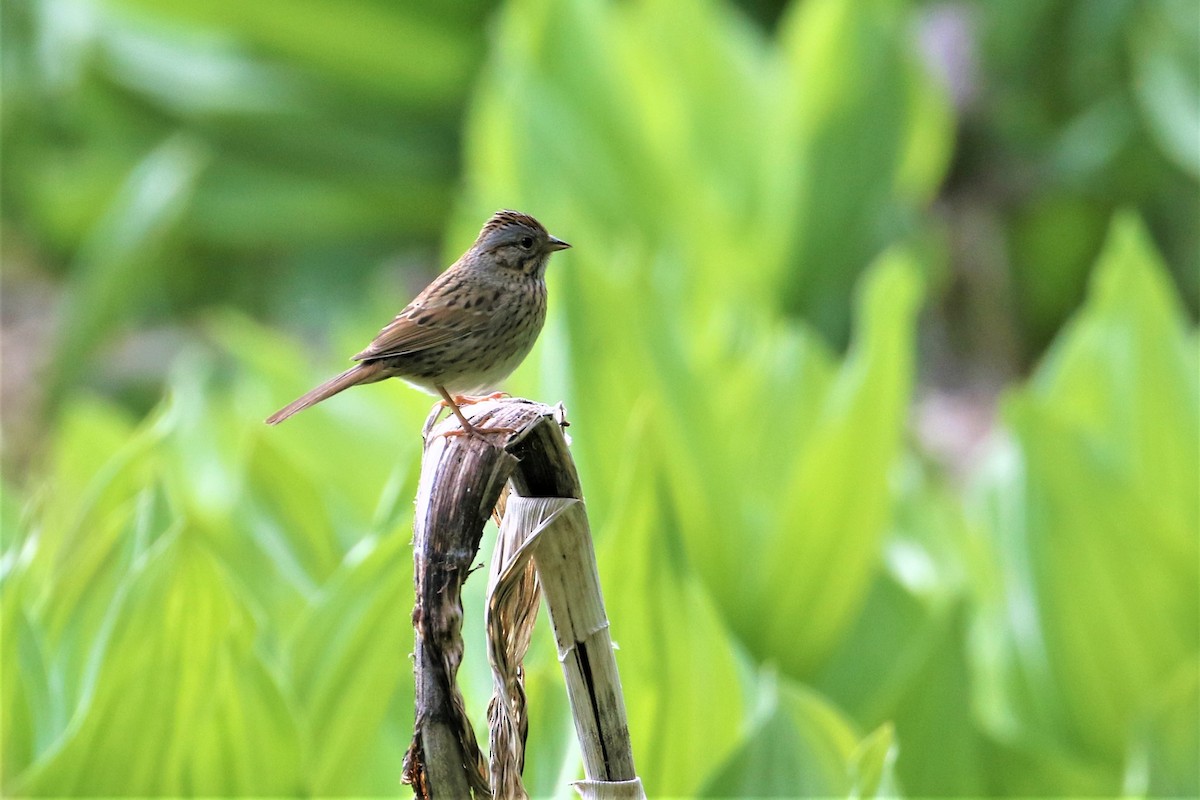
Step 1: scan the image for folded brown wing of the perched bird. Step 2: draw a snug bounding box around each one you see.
[354,275,492,361]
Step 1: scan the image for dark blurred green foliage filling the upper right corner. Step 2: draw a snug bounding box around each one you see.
[952,0,1200,360]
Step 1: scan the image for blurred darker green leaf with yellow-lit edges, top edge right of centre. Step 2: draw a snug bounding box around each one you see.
[780,0,953,344]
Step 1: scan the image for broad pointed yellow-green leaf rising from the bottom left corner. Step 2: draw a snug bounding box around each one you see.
[17,529,304,795]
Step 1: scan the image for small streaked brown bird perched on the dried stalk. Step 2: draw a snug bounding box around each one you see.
[266,211,570,435]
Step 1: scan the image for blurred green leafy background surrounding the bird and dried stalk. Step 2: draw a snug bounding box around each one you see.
[0,0,1200,796]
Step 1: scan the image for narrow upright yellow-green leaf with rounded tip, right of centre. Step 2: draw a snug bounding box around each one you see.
[760,253,920,674]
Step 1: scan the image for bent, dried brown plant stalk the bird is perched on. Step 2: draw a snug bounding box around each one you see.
[404,398,643,798]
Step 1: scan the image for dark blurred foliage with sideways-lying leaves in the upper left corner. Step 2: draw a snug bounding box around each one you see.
[2,0,491,401]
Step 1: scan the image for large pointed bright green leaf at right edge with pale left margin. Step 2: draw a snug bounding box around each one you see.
[974,216,1200,767]
